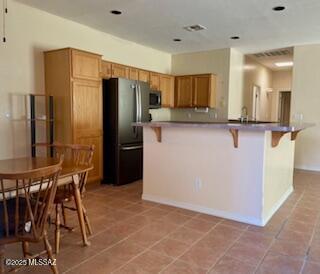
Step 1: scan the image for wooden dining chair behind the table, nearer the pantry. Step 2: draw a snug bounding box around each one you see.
[38,142,94,254]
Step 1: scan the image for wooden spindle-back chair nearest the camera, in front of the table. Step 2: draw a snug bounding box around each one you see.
[0,159,63,273]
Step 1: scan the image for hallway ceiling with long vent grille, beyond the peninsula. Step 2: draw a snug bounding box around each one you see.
[248,47,293,71]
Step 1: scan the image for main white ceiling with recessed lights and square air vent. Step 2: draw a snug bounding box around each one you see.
[17,0,320,53]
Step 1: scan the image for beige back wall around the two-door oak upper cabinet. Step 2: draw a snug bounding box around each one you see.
[171,49,230,120]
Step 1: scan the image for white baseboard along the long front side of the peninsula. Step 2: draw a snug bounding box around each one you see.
[142,194,263,226]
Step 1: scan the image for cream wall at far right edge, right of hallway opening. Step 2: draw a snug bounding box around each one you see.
[291,44,320,171]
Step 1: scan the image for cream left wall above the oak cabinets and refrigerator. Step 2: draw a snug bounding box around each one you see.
[0,0,171,159]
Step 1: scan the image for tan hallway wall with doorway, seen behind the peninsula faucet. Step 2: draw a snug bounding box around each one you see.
[243,56,272,121]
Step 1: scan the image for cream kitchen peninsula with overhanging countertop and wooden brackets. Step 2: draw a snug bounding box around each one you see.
[134,122,313,226]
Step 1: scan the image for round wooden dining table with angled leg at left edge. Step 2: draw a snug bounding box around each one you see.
[0,157,93,246]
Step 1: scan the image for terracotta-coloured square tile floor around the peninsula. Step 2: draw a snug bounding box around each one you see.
[6,171,320,274]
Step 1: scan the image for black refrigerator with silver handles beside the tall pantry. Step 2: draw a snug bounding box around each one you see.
[103,78,150,185]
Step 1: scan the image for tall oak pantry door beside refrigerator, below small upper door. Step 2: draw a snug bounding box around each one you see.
[72,81,102,180]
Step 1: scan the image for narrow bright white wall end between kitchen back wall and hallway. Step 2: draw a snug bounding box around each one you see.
[228,48,244,119]
